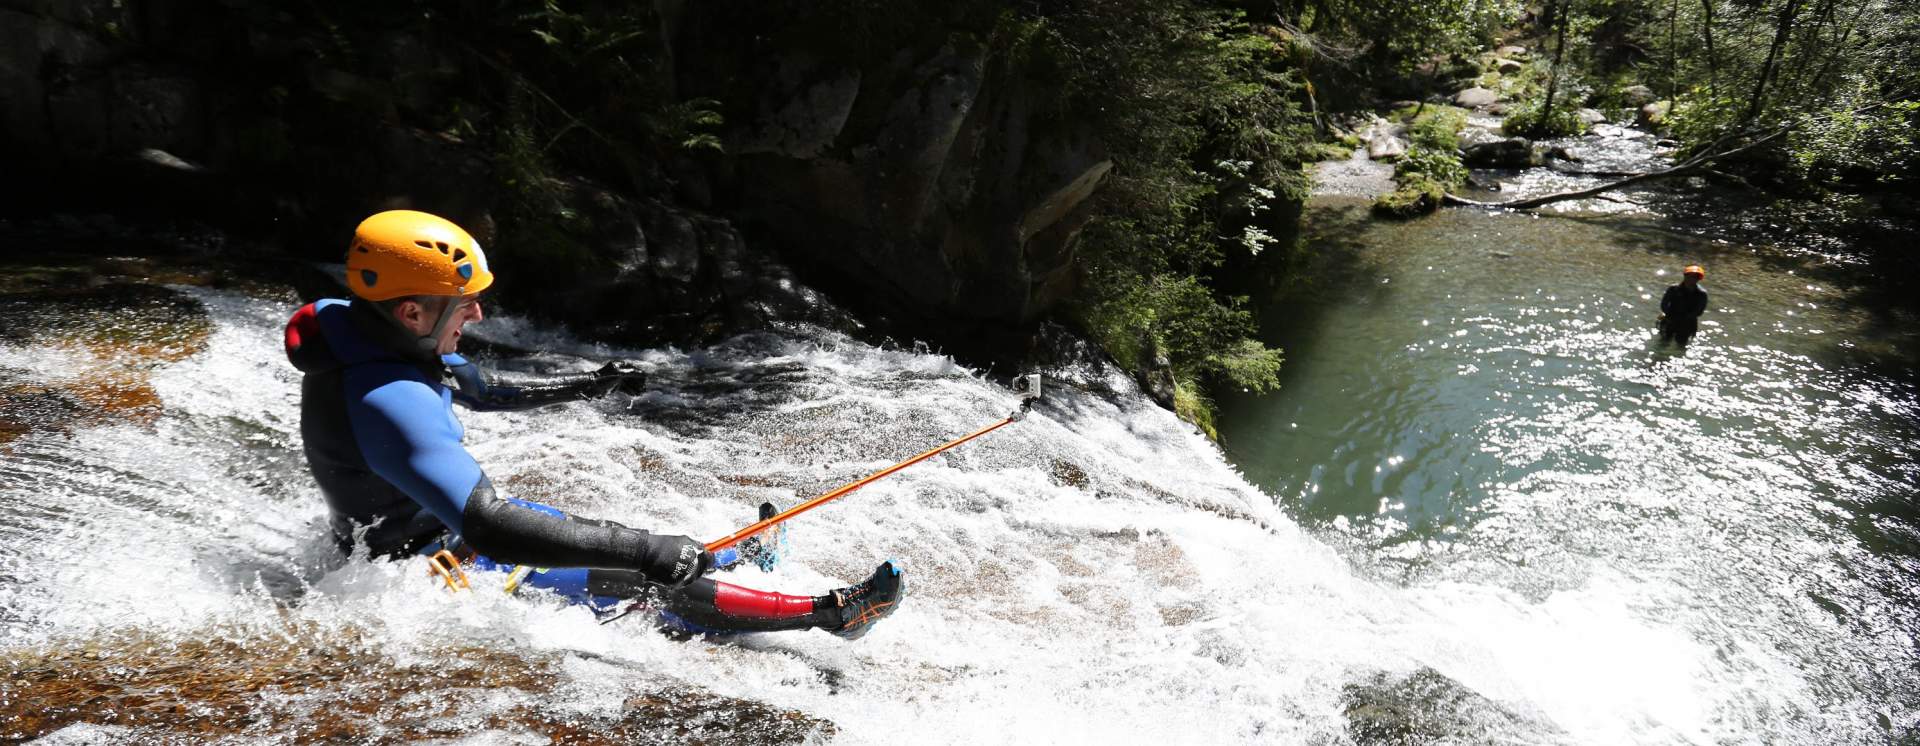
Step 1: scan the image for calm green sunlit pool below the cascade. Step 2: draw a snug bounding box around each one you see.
[1219,196,1920,740]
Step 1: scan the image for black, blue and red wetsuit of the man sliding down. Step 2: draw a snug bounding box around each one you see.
[286,299,845,633]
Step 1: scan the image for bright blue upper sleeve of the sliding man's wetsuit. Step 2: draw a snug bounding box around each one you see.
[348,378,484,533]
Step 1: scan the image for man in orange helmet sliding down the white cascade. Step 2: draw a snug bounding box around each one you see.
[286,211,904,639]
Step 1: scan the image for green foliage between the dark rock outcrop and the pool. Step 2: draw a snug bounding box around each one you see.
[1031,0,1305,412]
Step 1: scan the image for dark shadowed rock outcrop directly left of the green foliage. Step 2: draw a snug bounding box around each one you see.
[676,22,1114,337]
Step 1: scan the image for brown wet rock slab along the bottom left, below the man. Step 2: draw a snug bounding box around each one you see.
[0,627,833,744]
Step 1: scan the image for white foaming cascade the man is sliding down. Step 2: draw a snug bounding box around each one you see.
[0,266,1528,742]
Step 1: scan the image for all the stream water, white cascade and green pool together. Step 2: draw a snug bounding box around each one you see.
[0,149,1920,744]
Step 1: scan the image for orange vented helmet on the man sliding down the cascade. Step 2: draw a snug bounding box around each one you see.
[348,209,493,301]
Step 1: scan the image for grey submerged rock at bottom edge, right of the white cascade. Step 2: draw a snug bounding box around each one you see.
[1342,667,1563,746]
